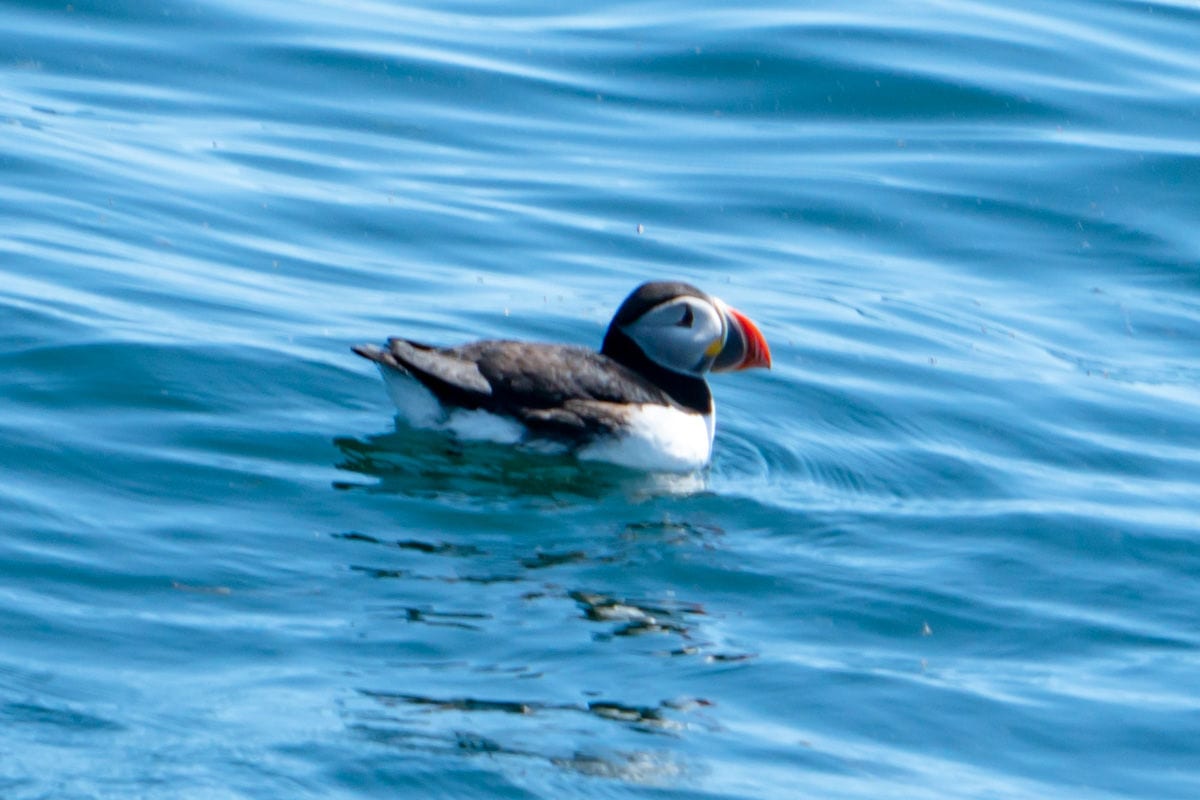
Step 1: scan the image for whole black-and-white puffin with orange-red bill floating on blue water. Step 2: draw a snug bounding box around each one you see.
[352,281,770,473]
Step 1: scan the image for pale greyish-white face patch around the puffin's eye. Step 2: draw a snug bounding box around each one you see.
[623,297,726,375]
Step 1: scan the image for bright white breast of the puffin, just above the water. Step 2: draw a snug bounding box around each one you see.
[580,404,714,473]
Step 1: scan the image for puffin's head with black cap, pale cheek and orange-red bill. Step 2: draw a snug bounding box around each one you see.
[604,281,770,377]
